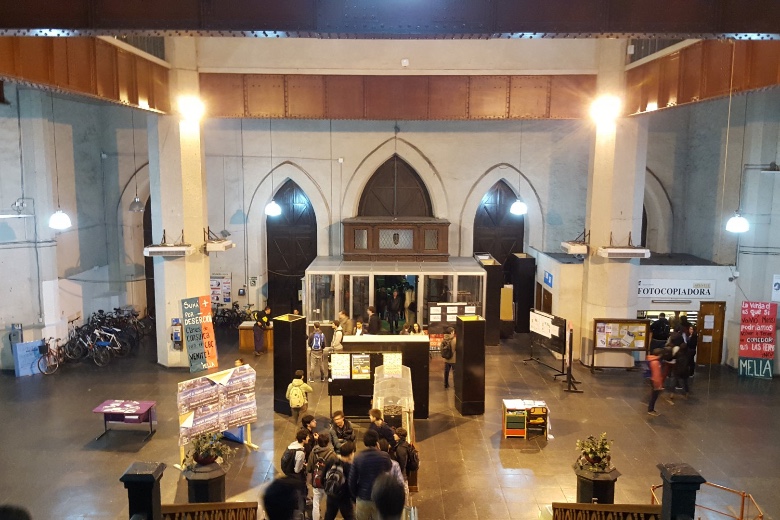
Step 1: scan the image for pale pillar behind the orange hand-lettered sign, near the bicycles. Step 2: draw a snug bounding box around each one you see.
[148,38,210,367]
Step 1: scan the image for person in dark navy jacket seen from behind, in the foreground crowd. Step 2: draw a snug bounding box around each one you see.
[347,430,392,520]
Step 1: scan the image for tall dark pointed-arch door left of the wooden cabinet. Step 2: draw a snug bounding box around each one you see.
[266,180,317,316]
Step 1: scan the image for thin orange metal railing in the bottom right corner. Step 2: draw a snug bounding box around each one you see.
[650,482,764,520]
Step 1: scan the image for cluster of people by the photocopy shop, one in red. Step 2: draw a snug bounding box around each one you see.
[646,312,698,417]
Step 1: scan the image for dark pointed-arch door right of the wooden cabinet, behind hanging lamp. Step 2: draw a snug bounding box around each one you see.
[474,181,525,265]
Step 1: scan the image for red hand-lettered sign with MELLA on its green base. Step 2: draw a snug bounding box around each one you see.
[739,301,777,379]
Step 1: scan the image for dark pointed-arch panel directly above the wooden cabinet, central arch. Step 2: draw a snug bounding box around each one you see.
[358,155,433,217]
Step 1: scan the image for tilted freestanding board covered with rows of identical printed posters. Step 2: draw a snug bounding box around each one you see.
[176,365,257,446]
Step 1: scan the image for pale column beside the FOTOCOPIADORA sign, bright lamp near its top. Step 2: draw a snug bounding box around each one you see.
[582,40,647,364]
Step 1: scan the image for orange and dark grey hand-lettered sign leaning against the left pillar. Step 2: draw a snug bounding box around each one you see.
[181,296,219,372]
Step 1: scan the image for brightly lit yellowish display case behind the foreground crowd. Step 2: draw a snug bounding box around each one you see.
[373,362,414,430]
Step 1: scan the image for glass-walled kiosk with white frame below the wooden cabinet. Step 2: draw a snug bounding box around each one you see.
[303,257,486,326]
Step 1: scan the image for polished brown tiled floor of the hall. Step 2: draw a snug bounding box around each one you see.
[0,332,780,520]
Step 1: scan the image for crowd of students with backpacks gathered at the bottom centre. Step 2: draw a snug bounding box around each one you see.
[263,409,419,520]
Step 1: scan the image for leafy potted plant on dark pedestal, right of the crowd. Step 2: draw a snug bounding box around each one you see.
[574,432,620,504]
